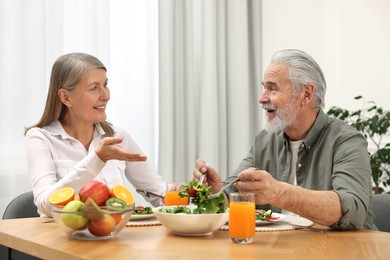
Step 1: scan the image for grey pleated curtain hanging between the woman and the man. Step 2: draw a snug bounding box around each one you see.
[158,0,262,182]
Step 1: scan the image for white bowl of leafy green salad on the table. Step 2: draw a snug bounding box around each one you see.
[153,181,229,236]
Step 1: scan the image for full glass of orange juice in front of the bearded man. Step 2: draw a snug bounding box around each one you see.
[229,192,256,244]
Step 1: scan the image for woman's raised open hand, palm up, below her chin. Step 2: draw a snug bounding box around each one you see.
[95,137,147,162]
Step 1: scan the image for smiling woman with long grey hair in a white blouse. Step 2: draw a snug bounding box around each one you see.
[25,53,176,216]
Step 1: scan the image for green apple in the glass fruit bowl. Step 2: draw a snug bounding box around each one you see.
[61,200,88,230]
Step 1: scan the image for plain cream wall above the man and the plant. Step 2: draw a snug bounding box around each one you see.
[262,0,390,110]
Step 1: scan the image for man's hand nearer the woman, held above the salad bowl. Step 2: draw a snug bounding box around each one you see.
[193,159,222,193]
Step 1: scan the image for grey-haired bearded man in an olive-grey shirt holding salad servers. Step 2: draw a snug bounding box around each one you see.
[193,50,376,230]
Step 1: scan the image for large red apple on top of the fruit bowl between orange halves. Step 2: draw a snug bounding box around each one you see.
[79,180,111,206]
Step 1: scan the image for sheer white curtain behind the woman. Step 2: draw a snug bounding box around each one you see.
[0,0,158,217]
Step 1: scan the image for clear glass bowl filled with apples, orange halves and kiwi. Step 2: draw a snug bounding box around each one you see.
[49,180,134,240]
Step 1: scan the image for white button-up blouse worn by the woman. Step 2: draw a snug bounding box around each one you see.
[26,121,167,216]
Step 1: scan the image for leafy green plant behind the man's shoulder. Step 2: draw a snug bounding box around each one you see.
[327,96,390,194]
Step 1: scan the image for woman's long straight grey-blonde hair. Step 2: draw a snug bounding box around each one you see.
[24,53,114,136]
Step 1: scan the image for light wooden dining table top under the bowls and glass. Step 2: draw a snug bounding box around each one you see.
[0,218,390,260]
